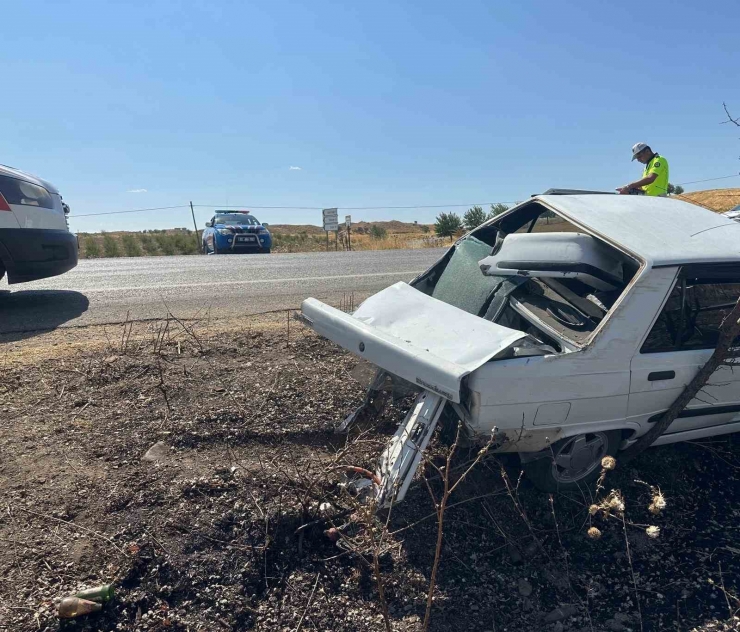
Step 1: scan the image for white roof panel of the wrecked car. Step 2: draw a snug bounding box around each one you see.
[533,195,740,266]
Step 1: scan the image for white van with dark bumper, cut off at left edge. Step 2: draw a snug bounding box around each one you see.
[0,165,77,283]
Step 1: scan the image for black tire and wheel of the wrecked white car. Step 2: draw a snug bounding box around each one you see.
[523,430,622,492]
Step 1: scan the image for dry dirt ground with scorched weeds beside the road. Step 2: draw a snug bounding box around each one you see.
[0,316,740,632]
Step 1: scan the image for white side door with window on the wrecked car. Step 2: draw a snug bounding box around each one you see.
[628,265,740,434]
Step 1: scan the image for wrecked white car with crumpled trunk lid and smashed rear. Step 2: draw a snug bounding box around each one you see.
[301,195,740,506]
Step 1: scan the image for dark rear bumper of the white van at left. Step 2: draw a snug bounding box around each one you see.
[0,228,77,283]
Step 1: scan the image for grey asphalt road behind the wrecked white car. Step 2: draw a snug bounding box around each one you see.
[0,249,444,334]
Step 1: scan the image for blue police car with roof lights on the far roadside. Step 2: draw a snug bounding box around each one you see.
[202,211,272,255]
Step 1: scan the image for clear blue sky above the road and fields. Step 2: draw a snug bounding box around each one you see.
[0,0,740,231]
